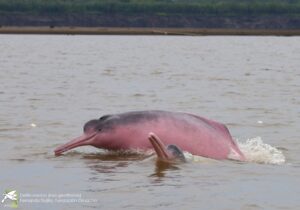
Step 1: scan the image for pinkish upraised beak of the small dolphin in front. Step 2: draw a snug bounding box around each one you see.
[148,133,172,161]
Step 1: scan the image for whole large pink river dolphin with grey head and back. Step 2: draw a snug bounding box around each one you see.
[54,110,245,161]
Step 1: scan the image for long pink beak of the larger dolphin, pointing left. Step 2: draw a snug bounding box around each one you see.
[54,132,97,156]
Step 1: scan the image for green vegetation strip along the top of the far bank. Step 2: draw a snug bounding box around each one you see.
[0,0,300,16]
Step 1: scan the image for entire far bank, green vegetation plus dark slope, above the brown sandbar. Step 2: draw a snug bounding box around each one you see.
[0,0,300,31]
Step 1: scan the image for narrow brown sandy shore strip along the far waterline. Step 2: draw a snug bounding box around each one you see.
[0,27,300,36]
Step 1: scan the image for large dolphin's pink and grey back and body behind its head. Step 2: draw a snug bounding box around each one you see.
[100,110,241,159]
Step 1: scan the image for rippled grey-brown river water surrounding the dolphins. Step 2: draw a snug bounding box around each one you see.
[0,35,300,210]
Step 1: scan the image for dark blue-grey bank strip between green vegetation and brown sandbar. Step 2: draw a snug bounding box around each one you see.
[0,13,300,30]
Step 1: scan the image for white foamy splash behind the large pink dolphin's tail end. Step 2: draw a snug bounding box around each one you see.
[237,136,285,164]
